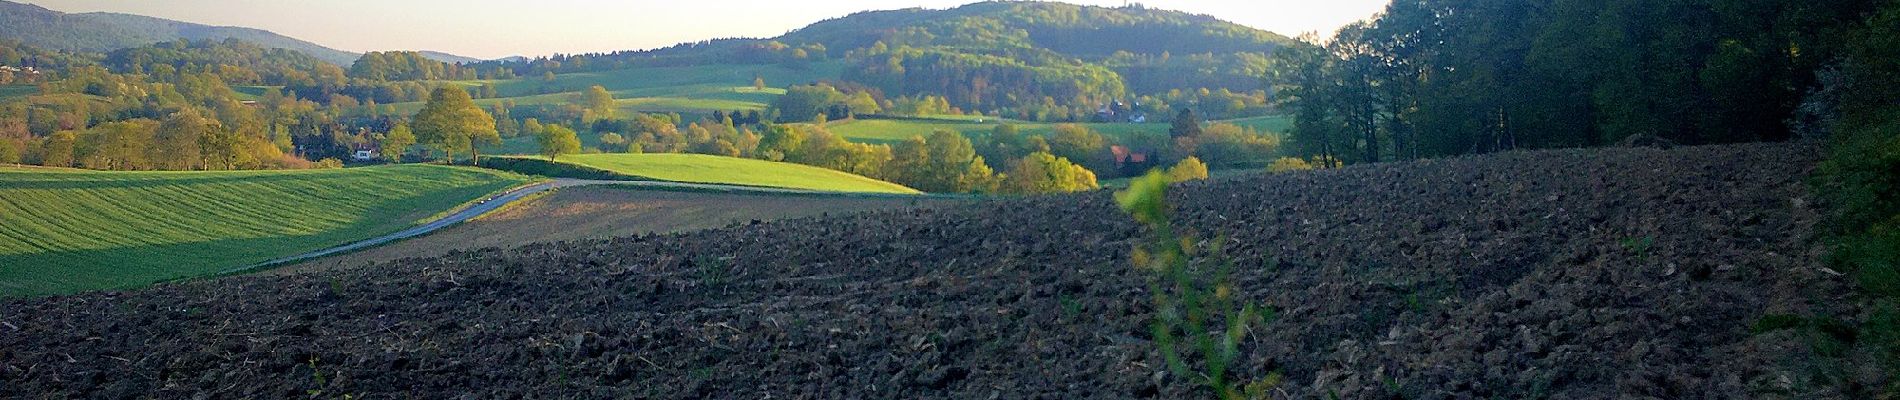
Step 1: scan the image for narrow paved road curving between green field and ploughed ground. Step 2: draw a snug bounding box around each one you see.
[222,178,912,275]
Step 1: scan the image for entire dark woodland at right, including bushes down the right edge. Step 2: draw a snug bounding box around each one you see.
[1271,0,1900,386]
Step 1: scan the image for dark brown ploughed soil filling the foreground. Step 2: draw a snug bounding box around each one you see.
[0,144,1879,398]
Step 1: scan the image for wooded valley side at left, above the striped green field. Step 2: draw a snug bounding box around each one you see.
[0,40,448,169]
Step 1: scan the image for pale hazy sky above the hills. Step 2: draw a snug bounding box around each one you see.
[25,0,1389,59]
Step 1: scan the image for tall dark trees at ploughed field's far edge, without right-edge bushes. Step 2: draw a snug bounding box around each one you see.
[1271,0,1875,163]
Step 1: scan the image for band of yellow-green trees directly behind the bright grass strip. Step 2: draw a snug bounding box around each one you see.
[521,83,1279,193]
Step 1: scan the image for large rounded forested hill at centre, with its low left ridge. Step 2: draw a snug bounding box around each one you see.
[473,2,1292,119]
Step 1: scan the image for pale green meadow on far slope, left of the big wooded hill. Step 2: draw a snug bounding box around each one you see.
[395,63,842,114]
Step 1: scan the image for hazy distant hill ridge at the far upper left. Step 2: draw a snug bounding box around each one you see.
[0,0,357,64]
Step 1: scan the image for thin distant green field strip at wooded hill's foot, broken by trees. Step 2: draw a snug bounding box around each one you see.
[825,116,1292,142]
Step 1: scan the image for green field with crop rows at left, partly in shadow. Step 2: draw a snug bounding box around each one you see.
[0,165,532,298]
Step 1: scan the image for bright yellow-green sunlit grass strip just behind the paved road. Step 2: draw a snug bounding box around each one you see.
[511,154,920,193]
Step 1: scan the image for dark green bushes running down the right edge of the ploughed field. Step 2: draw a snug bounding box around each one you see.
[1796,0,1900,381]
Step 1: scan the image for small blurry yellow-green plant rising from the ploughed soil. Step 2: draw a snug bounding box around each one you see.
[1115,173,1279,398]
